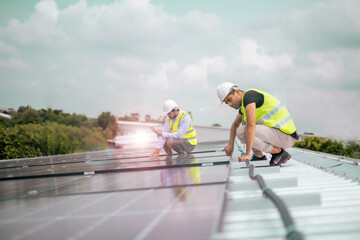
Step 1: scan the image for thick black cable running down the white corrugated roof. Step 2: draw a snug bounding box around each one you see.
[245,159,304,240]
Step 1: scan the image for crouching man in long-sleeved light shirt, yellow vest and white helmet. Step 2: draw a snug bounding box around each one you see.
[150,99,197,158]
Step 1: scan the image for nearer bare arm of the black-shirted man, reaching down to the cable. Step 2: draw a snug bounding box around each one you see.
[238,102,256,162]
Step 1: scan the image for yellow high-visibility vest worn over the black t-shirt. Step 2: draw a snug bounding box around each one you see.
[241,88,296,134]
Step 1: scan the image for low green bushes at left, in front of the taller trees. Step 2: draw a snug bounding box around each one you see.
[0,122,108,159]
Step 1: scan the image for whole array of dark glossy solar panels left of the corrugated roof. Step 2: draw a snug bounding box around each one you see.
[0,143,233,239]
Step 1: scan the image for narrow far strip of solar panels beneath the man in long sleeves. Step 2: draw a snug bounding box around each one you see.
[0,142,229,180]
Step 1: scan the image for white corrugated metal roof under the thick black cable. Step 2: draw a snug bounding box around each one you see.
[213,149,360,239]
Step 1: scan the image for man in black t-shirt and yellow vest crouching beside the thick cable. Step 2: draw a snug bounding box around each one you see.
[217,82,299,166]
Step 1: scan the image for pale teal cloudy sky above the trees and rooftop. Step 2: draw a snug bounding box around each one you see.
[0,0,360,138]
